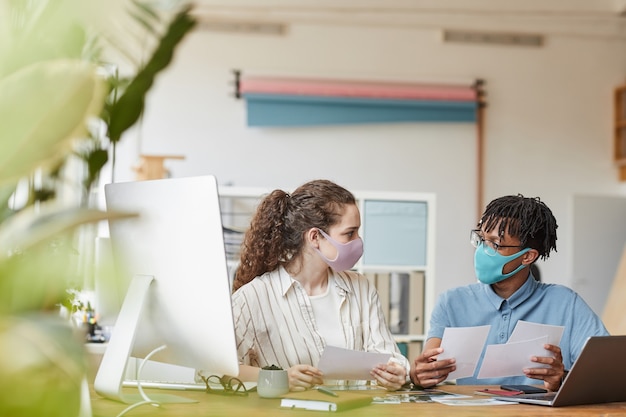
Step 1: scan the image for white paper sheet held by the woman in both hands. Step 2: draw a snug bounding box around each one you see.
[317,346,391,380]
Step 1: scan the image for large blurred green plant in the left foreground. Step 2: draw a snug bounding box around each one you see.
[0,0,194,417]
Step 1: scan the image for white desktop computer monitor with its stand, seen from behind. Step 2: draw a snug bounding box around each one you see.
[94,175,239,403]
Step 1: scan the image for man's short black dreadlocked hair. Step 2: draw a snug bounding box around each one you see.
[478,194,558,259]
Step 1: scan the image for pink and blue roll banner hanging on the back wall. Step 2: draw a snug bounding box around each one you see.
[237,77,480,127]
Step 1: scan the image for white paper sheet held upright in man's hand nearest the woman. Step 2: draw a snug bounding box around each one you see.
[437,325,491,380]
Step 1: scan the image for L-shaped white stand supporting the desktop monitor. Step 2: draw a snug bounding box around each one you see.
[94,275,197,405]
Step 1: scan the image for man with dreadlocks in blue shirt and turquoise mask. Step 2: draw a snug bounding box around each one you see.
[410,195,608,391]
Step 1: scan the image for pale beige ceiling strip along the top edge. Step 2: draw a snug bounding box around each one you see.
[194,0,626,39]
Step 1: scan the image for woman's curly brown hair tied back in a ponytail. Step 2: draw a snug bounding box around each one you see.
[233,180,356,291]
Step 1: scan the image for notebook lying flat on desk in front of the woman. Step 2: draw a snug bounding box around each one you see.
[280,390,372,411]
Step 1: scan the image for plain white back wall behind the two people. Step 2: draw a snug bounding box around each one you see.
[112,11,626,308]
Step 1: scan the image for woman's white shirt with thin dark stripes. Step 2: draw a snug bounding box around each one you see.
[232,267,409,374]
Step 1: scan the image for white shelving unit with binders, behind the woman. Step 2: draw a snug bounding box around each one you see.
[219,186,436,359]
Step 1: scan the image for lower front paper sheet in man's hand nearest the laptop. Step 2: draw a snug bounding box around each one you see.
[478,336,552,378]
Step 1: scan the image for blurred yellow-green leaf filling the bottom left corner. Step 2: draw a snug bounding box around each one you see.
[0,312,88,417]
